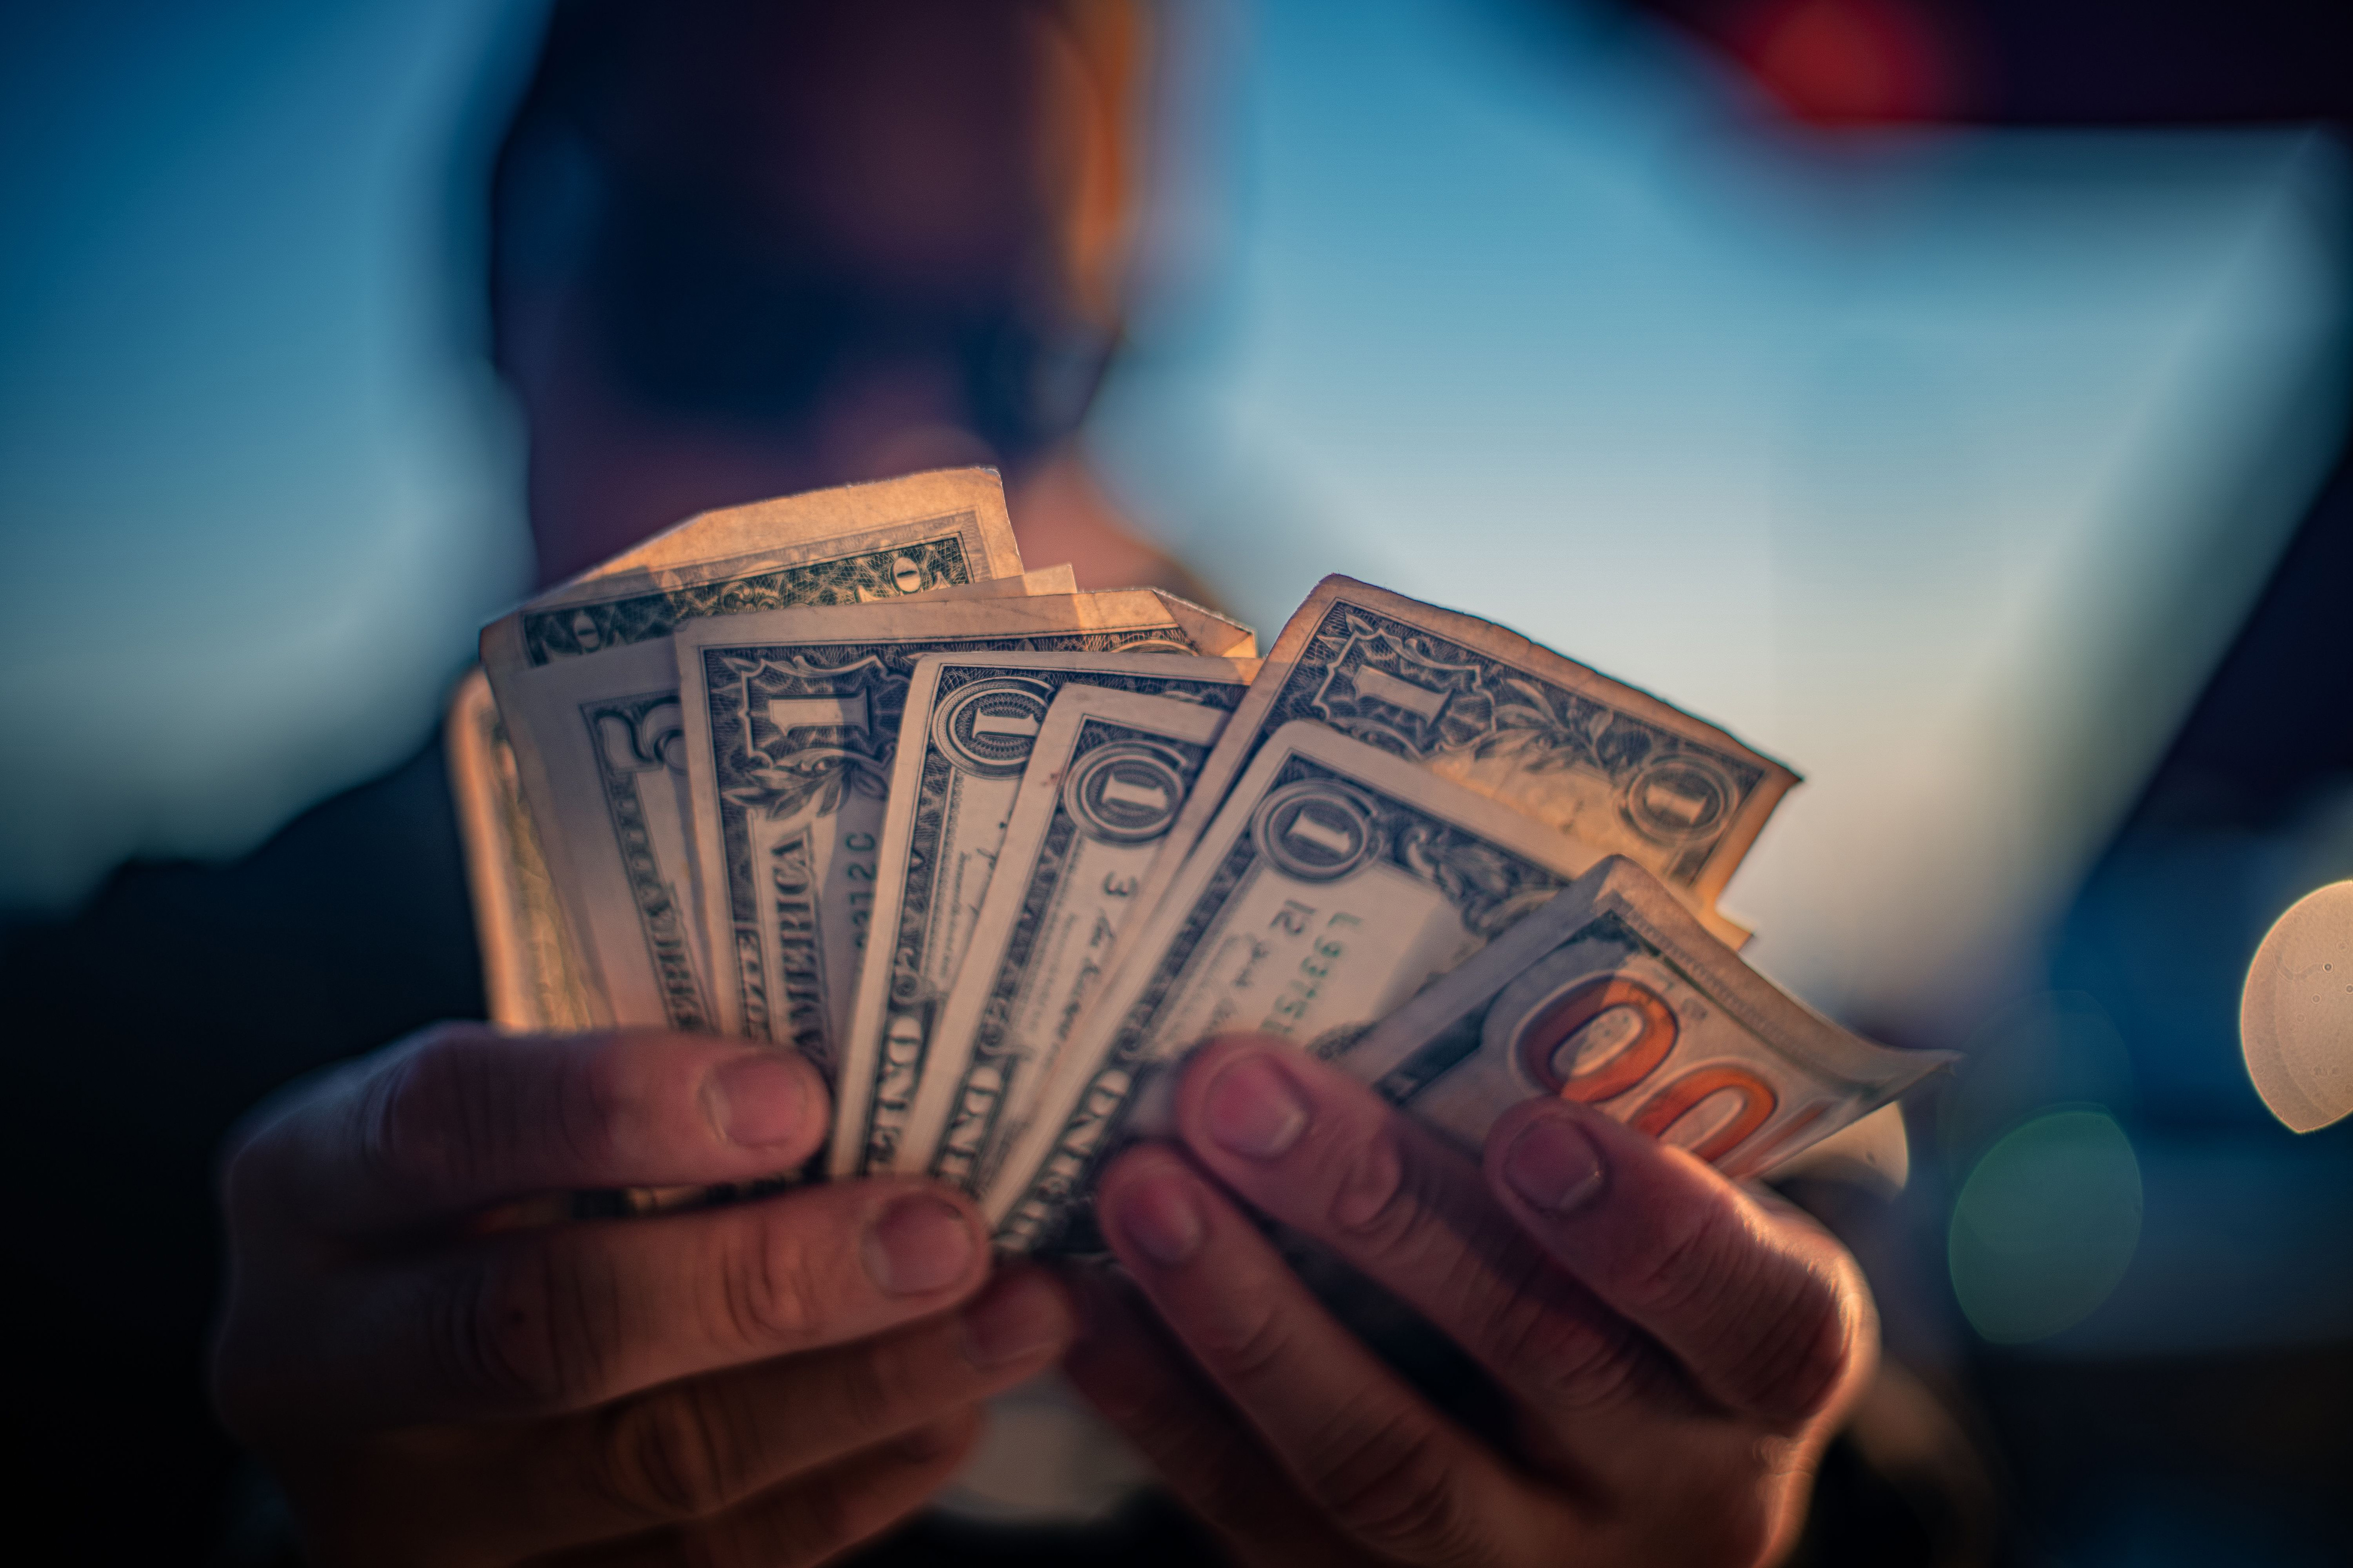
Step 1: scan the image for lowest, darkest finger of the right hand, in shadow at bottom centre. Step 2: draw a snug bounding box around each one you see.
[1061,1276,1362,1568]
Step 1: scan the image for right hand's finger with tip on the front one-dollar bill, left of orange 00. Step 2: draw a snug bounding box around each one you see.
[1177,1037,1690,1429]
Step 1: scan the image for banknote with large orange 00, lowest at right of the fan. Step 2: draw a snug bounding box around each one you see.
[1327,856,1956,1180]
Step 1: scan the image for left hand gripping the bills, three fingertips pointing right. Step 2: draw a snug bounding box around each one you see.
[214,1027,1073,1568]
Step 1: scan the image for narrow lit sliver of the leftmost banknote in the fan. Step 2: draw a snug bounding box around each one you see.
[443,668,595,1030]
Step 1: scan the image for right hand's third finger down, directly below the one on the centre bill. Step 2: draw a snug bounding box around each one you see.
[1097,1145,1574,1563]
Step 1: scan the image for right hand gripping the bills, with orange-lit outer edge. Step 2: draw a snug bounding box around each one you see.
[1066,1037,1875,1568]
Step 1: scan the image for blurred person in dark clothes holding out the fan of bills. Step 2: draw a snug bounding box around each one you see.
[0,0,1875,1563]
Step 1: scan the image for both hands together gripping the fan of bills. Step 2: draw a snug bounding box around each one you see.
[214,1027,1875,1568]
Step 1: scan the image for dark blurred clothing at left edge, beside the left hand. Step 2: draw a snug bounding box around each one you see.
[0,743,482,1563]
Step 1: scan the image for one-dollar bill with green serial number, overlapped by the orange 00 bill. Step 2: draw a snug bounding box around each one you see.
[981,719,1598,1251]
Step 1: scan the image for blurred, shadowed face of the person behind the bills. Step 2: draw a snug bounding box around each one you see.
[492,0,1134,581]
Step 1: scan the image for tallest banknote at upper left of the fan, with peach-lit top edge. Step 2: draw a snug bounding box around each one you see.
[482,470,1040,1030]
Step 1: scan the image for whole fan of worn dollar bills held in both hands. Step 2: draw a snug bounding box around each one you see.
[449,468,1946,1251]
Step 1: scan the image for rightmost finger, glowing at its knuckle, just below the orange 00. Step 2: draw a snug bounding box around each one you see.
[1487,1100,1875,1425]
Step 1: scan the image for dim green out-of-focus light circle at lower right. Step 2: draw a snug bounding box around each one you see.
[1946,1110,2141,1345]
